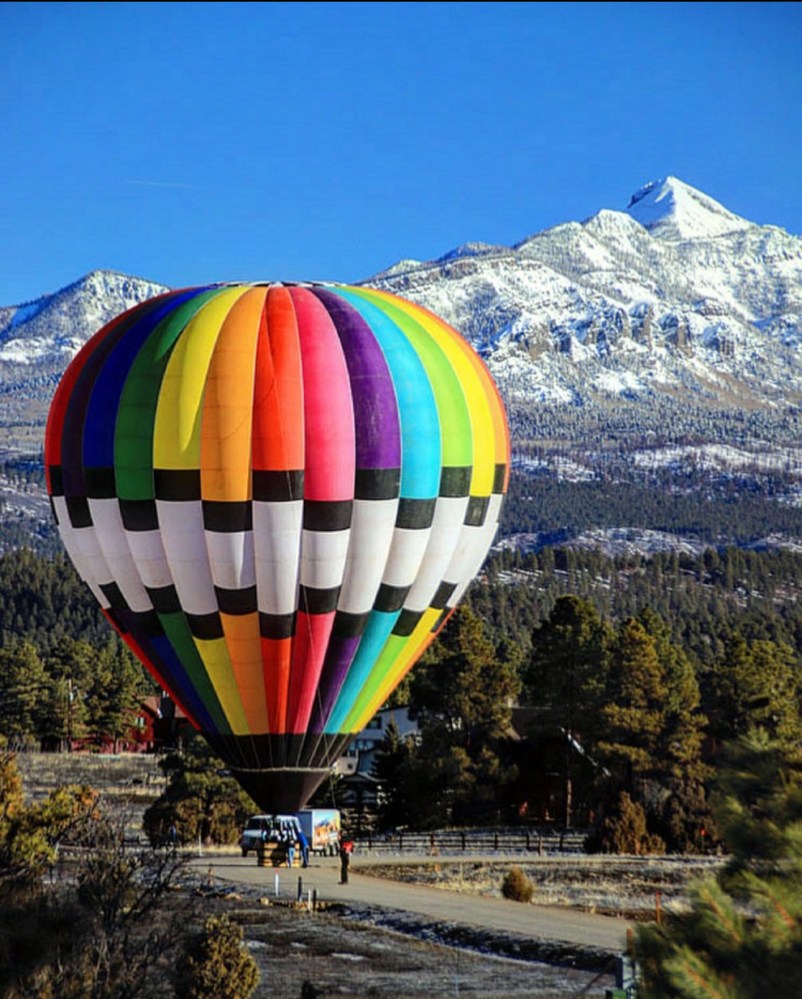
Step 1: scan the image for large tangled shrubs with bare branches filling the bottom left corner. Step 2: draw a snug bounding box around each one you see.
[0,800,185,999]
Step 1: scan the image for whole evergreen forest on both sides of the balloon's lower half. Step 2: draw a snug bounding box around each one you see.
[0,547,802,850]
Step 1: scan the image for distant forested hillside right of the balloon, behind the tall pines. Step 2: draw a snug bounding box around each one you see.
[466,547,802,663]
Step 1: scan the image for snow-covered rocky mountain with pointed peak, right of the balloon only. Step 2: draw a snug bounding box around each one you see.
[365,177,802,436]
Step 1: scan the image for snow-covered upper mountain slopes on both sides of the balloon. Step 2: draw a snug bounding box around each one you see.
[0,177,802,464]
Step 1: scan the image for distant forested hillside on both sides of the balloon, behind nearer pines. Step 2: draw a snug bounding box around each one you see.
[0,547,802,661]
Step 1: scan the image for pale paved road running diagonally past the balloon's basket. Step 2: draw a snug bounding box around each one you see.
[192,854,631,954]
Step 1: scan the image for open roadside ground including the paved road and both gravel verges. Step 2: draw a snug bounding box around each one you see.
[194,856,720,999]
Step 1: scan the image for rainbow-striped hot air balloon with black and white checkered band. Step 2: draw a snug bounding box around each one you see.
[45,283,509,812]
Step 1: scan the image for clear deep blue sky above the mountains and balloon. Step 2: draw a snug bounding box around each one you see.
[0,2,802,305]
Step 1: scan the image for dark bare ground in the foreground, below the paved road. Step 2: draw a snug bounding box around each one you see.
[184,866,614,999]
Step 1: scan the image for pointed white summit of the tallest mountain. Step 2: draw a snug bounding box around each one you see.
[627,177,751,240]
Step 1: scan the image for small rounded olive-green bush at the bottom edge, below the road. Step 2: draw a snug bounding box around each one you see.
[176,916,259,999]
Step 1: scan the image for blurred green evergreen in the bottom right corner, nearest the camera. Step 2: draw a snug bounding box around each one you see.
[636,730,802,999]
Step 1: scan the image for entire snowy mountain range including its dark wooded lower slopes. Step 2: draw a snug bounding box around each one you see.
[0,177,802,550]
